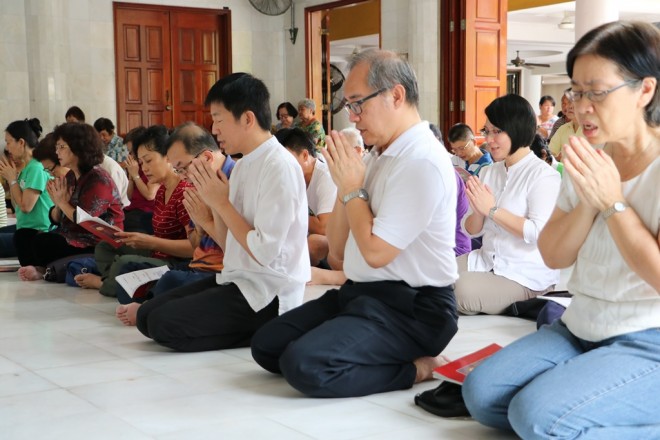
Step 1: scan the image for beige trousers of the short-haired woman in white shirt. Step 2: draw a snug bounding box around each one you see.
[454,254,555,315]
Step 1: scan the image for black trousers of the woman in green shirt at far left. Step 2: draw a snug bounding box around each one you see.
[14,229,94,267]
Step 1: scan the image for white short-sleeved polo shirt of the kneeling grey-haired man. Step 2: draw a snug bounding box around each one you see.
[344,121,458,287]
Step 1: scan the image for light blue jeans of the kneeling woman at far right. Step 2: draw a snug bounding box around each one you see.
[463,320,660,440]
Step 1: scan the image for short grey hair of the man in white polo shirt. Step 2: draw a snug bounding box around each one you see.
[348,49,419,107]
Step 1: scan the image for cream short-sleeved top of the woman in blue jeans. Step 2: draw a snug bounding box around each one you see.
[557,158,660,341]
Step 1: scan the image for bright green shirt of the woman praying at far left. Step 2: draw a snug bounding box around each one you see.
[16,159,53,231]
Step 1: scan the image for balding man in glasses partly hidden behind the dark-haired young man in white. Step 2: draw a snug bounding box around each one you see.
[116,122,236,325]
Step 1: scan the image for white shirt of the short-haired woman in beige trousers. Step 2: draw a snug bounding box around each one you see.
[461,151,561,290]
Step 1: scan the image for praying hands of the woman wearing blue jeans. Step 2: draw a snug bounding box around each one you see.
[563,136,624,215]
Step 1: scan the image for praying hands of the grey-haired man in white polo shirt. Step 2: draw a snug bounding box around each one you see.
[321,130,365,200]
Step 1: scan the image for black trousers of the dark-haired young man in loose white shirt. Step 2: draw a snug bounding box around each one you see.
[136,277,279,352]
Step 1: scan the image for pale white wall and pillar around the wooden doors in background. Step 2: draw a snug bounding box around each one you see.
[0,0,438,134]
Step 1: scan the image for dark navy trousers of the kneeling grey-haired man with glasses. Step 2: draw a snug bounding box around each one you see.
[252,281,458,397]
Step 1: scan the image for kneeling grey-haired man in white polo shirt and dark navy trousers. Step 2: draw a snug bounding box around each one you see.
[252,50,458,397]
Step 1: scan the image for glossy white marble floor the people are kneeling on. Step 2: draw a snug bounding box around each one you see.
[0,273,534,440]
